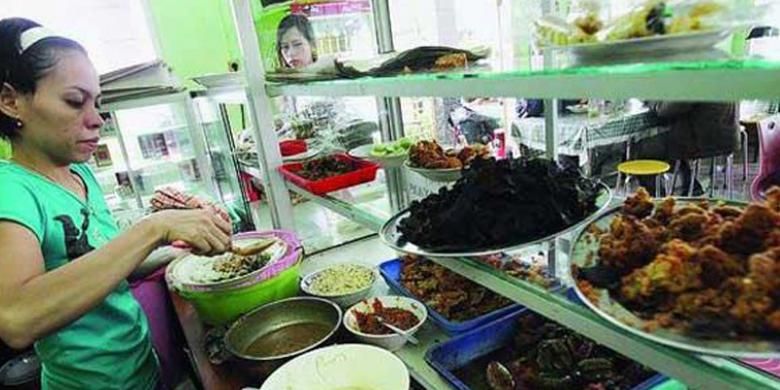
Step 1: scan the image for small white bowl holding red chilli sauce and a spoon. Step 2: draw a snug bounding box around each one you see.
[344,295,428,351]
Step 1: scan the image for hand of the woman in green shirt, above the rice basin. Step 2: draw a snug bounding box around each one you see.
[146,210,232,255]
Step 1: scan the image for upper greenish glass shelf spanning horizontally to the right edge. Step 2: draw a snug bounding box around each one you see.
[266,60,780,101]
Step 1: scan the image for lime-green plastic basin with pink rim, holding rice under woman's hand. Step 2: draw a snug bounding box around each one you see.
[166,230,302,326]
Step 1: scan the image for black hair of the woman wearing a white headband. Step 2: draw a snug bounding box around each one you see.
[0,18,87,139]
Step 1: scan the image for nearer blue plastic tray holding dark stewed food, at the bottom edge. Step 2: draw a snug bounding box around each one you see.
[425,292,667,390]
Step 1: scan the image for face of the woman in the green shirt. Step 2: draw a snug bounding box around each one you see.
[9,50,103,164]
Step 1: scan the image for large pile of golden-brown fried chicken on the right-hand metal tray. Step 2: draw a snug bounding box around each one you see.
[578,187,780,338]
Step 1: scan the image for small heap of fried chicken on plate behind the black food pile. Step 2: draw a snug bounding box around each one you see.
[409,141,490,169]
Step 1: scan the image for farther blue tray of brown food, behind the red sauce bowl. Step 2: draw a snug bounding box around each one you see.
[379,259,523,336]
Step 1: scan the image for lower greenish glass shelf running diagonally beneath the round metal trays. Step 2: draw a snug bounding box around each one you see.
[280,186,780,390]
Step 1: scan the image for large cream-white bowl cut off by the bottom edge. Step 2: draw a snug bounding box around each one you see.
[260,344,409,390]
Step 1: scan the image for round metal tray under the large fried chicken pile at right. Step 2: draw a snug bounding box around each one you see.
[570,198,780,359]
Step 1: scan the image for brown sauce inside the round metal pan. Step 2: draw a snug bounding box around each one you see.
[242,322,332,358]
